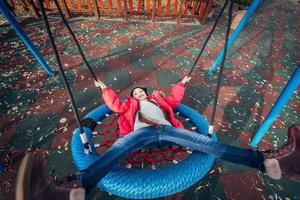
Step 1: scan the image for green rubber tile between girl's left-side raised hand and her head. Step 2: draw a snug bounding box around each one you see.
[104,70,131,89]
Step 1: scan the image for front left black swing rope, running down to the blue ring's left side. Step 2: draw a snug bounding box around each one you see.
[39,0,90,151]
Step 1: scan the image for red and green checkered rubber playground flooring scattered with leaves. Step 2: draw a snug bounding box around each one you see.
[0,0,300,199]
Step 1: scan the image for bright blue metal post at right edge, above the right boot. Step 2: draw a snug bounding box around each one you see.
[250,64,300,147]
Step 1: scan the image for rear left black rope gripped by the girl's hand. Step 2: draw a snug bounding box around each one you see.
[54,0,98,81]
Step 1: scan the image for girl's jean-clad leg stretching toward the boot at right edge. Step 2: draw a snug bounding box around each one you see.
[160,126,265,171]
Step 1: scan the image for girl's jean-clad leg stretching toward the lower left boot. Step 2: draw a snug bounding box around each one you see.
[81,127,158,190]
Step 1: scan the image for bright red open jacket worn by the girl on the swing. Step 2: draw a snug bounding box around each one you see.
[102,82,185,137]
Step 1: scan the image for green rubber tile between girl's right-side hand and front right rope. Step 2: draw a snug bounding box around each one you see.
[185,85,213,109]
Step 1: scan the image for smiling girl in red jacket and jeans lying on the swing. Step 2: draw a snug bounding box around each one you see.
[82,77,300,191]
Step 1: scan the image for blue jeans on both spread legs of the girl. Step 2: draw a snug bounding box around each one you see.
[82,125,265,188]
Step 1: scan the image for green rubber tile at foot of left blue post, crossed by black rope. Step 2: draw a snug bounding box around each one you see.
[44,70,76,89]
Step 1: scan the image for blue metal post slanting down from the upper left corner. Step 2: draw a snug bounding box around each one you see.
[0,2,53,76]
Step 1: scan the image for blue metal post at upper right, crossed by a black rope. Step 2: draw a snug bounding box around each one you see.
[208,0,261,74]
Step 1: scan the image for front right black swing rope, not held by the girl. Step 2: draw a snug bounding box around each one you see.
[210,1,233,131]
